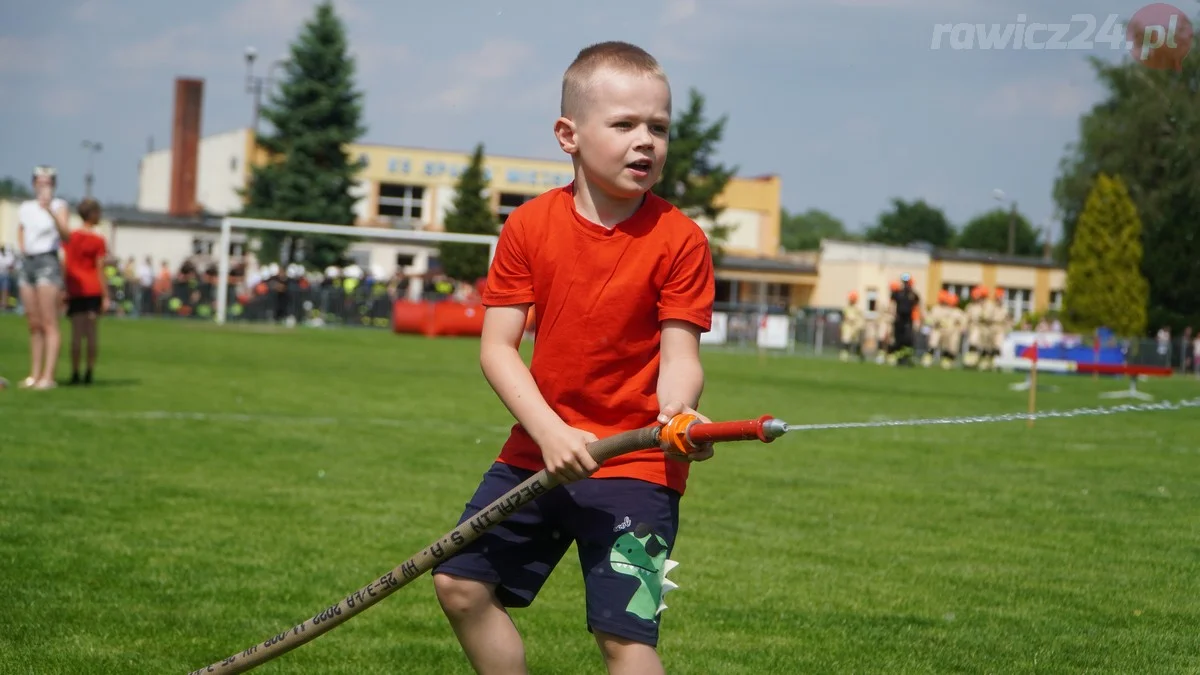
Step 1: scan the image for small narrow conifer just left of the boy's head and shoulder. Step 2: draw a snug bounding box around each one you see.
[438,144,499,281]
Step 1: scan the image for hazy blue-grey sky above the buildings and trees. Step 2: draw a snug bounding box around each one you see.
[0,0,1161,241]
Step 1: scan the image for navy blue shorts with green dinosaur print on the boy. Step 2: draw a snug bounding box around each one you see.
[433,462,679,646]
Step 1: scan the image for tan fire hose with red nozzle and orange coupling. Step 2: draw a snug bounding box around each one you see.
[188,414,788,675]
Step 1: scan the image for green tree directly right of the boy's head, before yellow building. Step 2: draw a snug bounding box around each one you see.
[654,89,737,263]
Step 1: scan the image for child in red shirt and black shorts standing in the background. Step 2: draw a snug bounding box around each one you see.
[62,199,108,384]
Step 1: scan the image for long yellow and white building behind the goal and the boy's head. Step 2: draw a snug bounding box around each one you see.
[138,129,812,289]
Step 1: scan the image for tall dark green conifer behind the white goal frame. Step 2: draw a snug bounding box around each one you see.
[236,1,365,268]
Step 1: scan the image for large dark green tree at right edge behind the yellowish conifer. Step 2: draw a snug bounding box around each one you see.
[1054,18,1200,330]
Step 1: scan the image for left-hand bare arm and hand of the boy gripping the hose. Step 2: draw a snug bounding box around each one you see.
[479,305,599,483]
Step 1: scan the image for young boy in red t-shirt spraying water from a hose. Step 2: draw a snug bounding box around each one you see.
[433,42,714,675]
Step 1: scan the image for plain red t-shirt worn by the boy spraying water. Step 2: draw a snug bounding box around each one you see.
[482,185,715,494]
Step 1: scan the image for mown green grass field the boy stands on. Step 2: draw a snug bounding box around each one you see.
[0,316,1200,674]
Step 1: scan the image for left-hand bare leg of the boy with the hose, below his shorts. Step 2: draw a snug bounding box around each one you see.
[433,574,527,675]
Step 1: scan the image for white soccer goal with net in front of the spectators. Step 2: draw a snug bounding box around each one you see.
[211,217,499,327]
